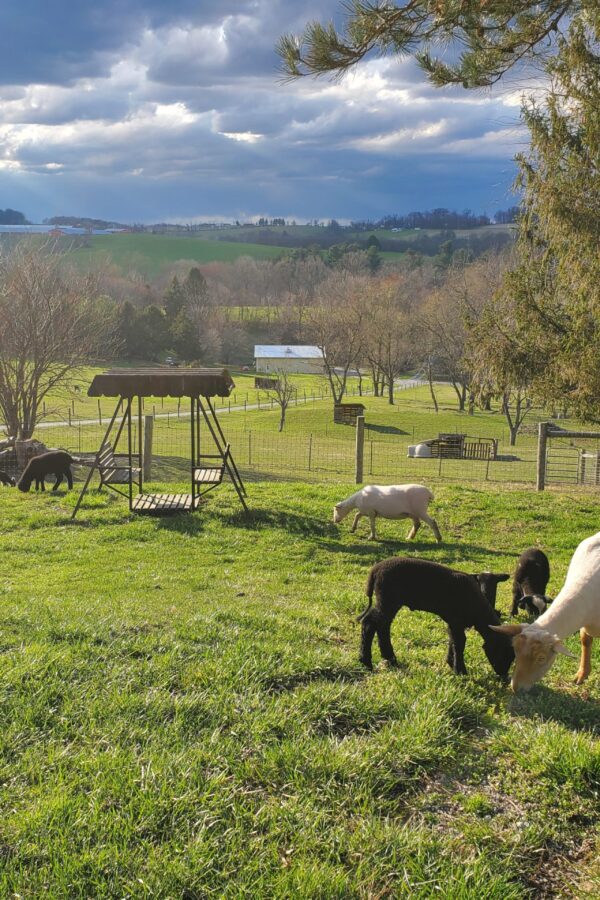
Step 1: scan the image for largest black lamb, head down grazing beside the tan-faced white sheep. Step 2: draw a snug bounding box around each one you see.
[358,557,515,678]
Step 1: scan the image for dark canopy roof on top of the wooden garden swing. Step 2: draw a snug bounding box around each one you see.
[88,367,235,397]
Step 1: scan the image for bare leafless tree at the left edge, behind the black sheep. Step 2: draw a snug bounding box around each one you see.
[0,241,112,440]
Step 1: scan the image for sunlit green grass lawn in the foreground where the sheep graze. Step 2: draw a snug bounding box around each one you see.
[0,483,600,900]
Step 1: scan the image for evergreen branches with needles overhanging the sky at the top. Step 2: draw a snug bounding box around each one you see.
[277,0,598,87]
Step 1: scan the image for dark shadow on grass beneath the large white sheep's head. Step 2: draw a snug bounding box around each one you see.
[509,684,600,734]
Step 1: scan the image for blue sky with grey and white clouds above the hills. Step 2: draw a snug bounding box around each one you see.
[0,0,526,223]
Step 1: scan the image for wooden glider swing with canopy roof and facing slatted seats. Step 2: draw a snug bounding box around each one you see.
[71,369,248,519]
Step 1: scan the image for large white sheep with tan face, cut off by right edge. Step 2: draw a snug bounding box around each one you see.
[490,532,600,691]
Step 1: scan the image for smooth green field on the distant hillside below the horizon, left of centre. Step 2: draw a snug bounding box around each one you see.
[64,234,288,277]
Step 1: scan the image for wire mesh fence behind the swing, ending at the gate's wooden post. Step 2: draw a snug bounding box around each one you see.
[2,414,536,485]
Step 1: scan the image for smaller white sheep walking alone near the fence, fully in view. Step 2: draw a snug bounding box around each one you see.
[333,484,442,541]
